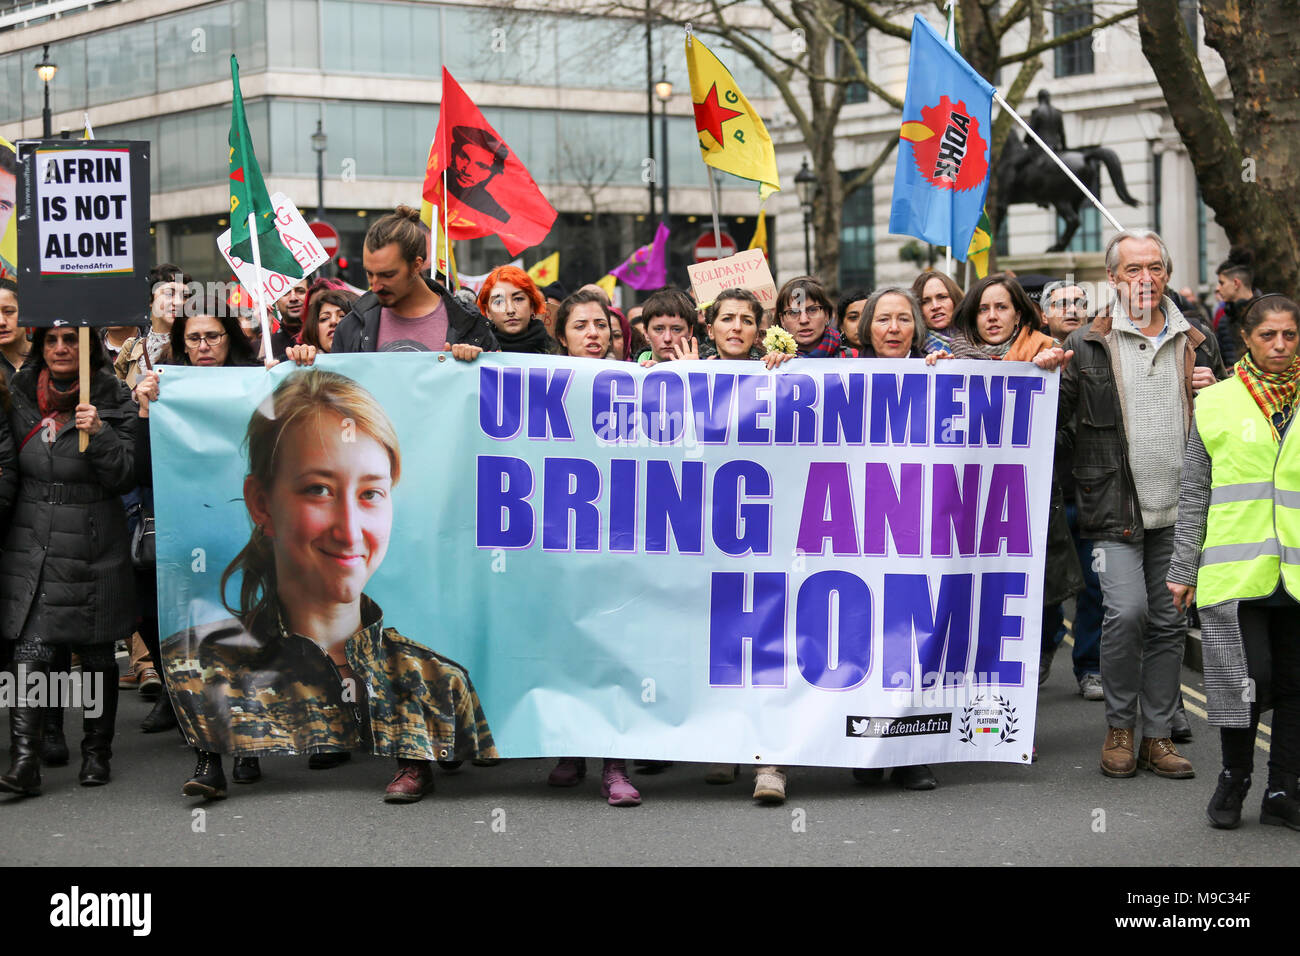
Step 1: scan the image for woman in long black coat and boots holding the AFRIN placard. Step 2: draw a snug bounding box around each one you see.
[0,328,135,795]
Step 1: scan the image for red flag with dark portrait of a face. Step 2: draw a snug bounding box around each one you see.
[424,68,555,256]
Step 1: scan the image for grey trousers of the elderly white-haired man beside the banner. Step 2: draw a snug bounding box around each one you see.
[1093,527,1187,737]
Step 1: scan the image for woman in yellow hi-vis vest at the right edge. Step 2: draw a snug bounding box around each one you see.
[1169,294,1300,830]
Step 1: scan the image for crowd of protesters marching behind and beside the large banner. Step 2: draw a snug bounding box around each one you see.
[0,207,1300,830]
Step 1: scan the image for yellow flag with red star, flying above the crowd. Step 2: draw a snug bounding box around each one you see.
[686,33,781,199]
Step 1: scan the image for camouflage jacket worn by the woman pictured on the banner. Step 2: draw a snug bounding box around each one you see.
[163,596,498,760]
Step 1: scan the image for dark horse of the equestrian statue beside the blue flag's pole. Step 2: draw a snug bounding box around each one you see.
[993,135,1140,252]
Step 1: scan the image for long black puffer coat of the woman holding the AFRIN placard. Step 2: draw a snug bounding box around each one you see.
[0,364,137,646]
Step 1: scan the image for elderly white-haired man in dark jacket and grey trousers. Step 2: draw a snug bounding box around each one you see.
[1058,230,1216,778]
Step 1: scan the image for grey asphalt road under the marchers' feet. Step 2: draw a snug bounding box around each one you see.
[0,648,1297,866]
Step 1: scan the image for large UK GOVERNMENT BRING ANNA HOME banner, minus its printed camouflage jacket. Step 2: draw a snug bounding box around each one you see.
[151,354,1057,766]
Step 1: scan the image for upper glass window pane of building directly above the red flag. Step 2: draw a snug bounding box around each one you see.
[442,7,556,86]
